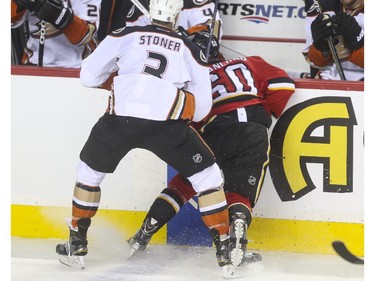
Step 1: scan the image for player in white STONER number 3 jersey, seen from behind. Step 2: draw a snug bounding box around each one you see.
[56,0,244,275]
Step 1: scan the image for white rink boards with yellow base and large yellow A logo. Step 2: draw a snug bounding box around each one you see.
[11,67,364,255]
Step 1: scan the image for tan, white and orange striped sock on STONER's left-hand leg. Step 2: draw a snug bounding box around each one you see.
[72,182,101,227]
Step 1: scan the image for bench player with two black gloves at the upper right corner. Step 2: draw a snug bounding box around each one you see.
[302,0,364,81]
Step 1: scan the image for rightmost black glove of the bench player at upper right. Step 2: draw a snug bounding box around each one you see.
[332,12,365,50]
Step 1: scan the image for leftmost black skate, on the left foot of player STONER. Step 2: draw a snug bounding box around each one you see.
[56,218,91,269]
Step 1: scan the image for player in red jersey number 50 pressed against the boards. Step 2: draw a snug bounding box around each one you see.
[129,31,295,263]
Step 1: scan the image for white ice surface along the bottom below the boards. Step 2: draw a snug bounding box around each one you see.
[11,235,367,281]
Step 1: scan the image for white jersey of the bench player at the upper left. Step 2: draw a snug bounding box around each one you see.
[12,0,101,68]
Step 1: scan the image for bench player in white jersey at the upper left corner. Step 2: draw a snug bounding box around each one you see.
[11,0,101,68]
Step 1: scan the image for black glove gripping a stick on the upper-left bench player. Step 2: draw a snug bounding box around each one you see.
[34,0,74,29]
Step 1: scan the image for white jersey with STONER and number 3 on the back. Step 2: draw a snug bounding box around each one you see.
[80,25,212,122]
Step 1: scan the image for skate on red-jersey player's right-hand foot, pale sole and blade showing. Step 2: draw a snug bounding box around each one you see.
[229,212,248,266]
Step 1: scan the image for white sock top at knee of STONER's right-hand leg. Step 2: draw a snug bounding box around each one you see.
[188,163,223,193]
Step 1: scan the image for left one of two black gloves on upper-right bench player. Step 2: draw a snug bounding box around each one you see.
[311,14,333,51]
